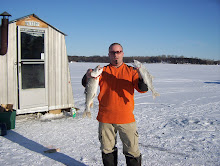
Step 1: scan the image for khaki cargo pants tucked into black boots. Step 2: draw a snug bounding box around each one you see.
[99,122,140,157]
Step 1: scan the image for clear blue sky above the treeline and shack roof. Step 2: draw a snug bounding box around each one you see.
[0,0,220,60]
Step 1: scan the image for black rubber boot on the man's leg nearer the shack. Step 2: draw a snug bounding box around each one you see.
[102,148,118,166]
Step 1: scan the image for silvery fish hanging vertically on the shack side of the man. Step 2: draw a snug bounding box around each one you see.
[83,65,103,118]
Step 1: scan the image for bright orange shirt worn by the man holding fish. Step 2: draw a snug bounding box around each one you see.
[97,63,146,124]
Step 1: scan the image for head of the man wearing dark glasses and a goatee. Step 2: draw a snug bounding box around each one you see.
[108,43,124,67]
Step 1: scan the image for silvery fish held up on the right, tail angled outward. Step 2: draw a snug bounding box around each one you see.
[133,60,160,99]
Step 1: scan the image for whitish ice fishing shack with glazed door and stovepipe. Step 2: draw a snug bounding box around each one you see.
[0,12,74,114]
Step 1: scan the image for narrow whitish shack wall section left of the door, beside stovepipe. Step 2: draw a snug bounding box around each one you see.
[0,23,17,106]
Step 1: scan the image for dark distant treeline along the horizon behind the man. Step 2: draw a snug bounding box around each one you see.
[68,55,220,65]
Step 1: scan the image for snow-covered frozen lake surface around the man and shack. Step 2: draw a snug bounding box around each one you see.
[0,63,220,166]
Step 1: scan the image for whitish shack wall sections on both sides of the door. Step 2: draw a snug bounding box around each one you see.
[0,22,74,110]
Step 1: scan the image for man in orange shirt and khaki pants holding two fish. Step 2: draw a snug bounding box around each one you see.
[82,43,148,166]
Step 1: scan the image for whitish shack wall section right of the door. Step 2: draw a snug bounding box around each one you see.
[47,27,74,110]
